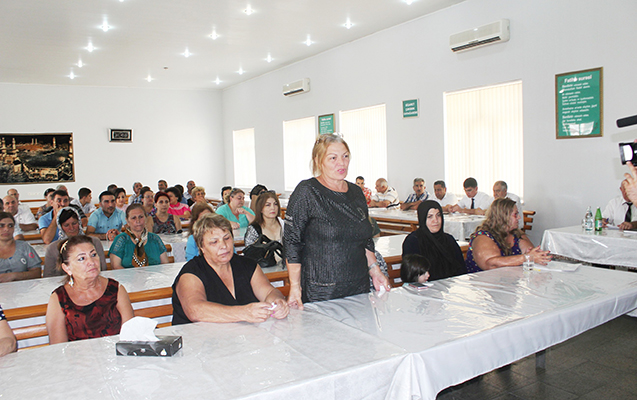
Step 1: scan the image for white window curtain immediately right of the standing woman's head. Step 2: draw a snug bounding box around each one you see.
[339,104,387,187]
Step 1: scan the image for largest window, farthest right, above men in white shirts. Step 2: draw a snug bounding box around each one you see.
[444,81,524,197]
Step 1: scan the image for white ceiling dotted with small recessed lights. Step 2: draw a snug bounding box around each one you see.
[0,0,464,89]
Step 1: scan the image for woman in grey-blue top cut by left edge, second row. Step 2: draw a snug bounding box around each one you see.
[0,211,42,282]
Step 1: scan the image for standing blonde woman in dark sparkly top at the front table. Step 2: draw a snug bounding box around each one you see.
[283,135,390,309]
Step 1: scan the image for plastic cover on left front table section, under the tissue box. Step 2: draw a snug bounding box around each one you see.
[0,310,406,400]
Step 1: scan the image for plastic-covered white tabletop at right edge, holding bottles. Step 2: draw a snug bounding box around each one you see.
[542,225,637,268]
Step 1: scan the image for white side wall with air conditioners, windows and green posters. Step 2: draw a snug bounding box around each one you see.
[222,0,637,243]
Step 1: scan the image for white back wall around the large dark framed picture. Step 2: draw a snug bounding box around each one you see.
[0,84,225,201]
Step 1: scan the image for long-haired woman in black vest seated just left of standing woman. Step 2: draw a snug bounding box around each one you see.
[244,192,284,262]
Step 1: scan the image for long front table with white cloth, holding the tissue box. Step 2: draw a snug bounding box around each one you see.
[0,267,637,400]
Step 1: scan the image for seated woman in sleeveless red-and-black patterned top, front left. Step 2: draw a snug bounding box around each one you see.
[46,235,134,344]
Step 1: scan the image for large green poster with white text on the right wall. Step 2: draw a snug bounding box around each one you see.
[555,67,604,139]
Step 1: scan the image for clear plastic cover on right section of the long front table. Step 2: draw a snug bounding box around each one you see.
[306,267,637,399]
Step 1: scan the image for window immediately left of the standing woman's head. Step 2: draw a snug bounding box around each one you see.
[283,117,316,191]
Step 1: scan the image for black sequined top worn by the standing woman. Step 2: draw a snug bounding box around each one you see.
[283,178,374,302]
